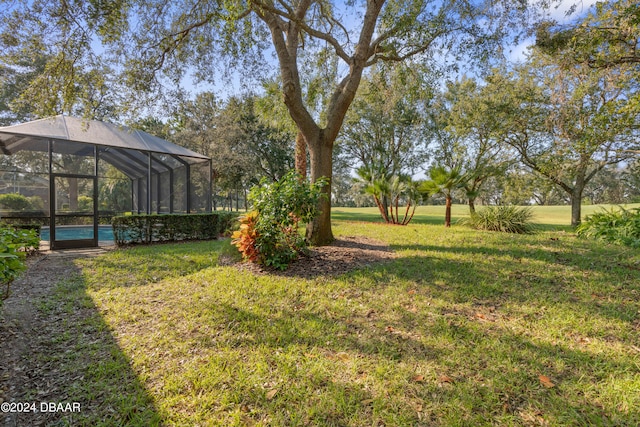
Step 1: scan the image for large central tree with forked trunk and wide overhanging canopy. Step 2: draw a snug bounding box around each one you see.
[0,0,548,244]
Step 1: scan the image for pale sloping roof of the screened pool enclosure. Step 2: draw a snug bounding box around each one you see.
[0,115,209,161]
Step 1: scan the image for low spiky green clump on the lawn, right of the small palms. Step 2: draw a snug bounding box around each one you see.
[460,206,534,234]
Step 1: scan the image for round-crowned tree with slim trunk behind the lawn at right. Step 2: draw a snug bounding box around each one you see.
[483,57,639,226]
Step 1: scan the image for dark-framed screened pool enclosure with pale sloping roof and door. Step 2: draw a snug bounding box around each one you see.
[0,115,211,249]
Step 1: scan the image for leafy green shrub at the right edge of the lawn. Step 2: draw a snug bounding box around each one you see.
[576,207,640,248]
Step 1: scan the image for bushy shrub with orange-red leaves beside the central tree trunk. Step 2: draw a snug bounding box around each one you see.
[233,171,327,270]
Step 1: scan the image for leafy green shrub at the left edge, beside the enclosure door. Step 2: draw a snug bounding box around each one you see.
[0,225,40,299]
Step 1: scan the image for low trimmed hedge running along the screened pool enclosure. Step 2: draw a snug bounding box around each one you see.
[111,211,238,245]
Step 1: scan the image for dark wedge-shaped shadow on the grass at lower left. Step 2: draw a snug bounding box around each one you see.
[0,255,161,426]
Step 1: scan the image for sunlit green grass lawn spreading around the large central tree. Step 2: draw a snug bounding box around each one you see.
[36,211,640,426]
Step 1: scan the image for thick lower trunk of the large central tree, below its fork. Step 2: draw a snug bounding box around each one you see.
[306,132,333,246]
